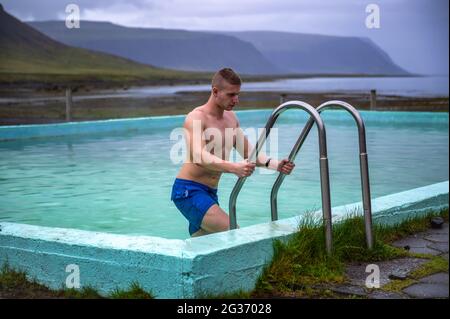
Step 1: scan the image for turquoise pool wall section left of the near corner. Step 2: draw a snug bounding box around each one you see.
[0,224,184,298]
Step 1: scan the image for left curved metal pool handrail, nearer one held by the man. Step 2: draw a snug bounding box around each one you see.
[229,101,333,253]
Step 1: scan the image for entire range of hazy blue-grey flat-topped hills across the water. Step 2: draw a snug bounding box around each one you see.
[29,21,408,75]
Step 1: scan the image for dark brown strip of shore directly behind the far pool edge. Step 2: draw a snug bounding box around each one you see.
[0,91,449,125]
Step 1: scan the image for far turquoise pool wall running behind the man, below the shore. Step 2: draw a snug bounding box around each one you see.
[0,110,448,141]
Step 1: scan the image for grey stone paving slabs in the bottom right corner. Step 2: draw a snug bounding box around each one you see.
[328,223,449,299]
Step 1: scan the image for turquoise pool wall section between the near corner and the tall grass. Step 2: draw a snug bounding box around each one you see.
[179,221,296,298]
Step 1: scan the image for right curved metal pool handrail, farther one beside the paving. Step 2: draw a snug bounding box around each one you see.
[270,101,373,249]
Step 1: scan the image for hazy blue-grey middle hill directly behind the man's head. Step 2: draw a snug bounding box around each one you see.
[29,21,281,75]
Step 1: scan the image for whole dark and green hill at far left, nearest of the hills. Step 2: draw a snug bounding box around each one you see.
[0,5,206,86]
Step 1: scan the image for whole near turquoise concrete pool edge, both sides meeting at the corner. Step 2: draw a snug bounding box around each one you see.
[0,181,449,298]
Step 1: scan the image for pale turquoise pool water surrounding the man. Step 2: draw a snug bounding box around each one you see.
[0,111,449,239]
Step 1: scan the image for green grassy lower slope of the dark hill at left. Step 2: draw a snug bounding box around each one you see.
[0,28,211,86]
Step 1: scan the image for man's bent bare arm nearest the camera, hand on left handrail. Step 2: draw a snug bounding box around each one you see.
[184,113,255,177]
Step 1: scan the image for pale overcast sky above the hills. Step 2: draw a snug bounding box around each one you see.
[0,0,449,74]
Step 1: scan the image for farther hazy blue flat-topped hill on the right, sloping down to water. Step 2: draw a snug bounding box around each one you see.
[226,31,409,75]
